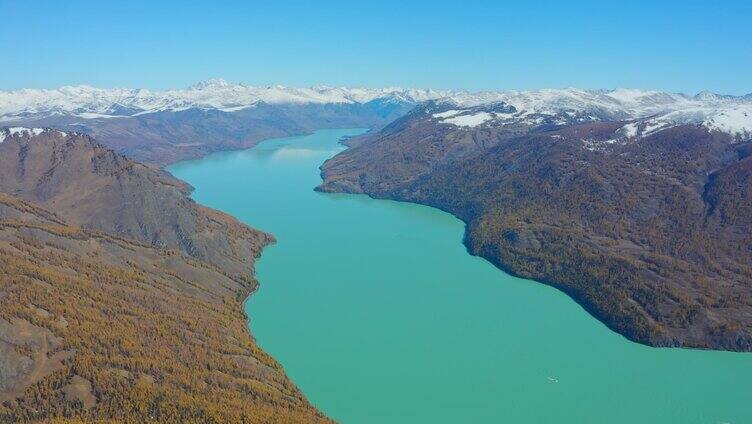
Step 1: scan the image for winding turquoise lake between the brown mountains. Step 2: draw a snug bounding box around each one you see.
[169,130,752,424]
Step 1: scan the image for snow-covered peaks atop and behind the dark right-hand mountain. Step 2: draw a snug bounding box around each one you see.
[427,88,752,138]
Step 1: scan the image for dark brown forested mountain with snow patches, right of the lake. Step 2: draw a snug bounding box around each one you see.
[319,109,752,350]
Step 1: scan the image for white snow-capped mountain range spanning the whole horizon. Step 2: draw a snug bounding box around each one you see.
[0,79,752,134]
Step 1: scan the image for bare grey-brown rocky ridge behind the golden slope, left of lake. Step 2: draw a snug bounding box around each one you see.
[0,129,271,275]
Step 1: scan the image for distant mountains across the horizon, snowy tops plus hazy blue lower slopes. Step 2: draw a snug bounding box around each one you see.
[0,79,752,166]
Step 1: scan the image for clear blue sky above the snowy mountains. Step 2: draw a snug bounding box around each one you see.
[0,0,752,94]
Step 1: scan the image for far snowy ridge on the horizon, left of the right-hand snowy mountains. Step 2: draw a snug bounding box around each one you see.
[0,79,450,122]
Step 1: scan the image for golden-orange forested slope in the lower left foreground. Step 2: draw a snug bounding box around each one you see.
[0,194,327,423]
